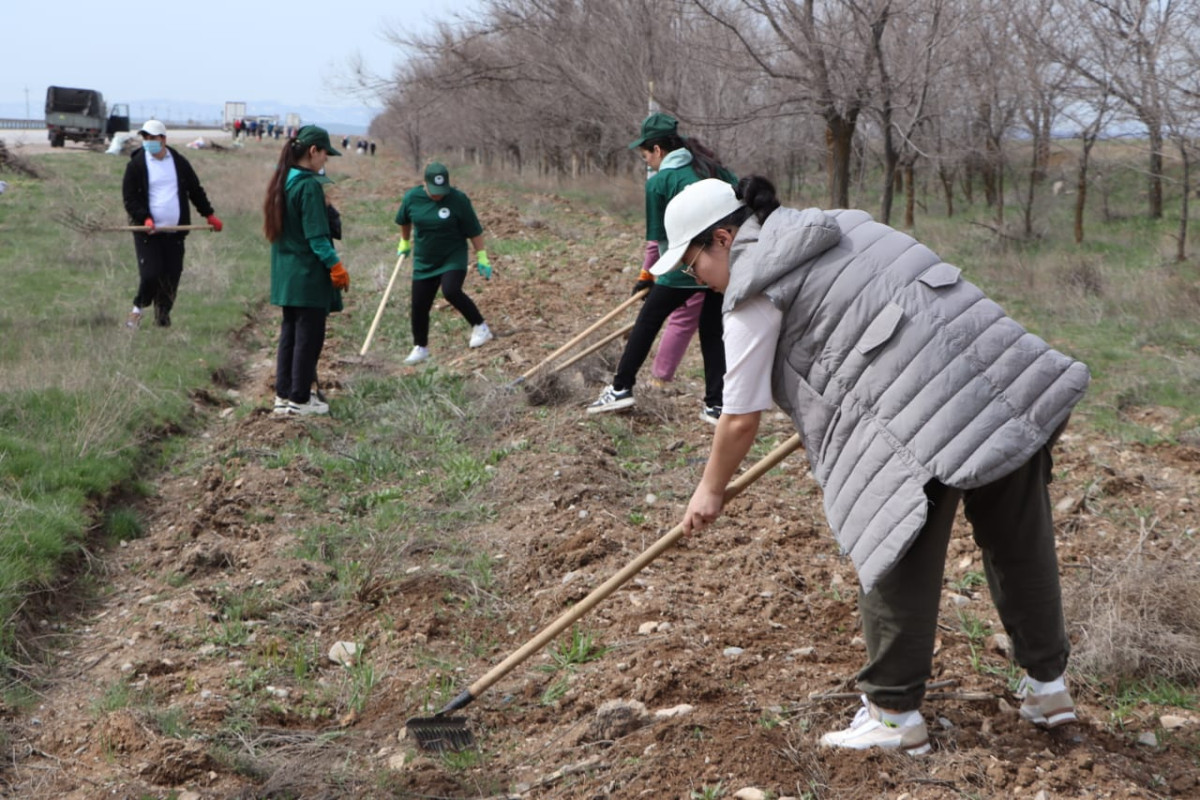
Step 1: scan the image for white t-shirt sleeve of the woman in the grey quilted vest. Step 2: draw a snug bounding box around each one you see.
[721,294,784,414]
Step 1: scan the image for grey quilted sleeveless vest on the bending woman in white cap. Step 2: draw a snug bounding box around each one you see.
[724,207,1088,591]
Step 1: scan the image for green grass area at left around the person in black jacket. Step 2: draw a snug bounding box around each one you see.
[0,146,265,654]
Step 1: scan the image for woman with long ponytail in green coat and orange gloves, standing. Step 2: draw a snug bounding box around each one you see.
[263,125,350,415]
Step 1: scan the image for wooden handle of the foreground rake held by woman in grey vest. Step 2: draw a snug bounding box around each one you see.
[451,433,800,716]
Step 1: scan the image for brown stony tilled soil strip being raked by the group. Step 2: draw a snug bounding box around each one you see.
[2,170,1200,800]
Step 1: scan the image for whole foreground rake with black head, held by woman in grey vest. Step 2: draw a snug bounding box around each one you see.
[404,434,800,751]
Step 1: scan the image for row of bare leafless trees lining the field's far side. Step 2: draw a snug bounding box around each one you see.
[360,0,1200,254]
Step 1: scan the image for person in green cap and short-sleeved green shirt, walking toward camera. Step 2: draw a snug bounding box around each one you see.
[396,162,492,365]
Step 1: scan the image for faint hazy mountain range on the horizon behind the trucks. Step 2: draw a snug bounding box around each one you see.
[0,95,379,136]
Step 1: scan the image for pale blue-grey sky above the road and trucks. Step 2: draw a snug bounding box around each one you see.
[0,0,482,119]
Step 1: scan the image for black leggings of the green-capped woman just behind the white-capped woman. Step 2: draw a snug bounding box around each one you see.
[612,284,725,407]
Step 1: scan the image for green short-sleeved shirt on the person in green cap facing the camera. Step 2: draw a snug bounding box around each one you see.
[396,184,484,281]
